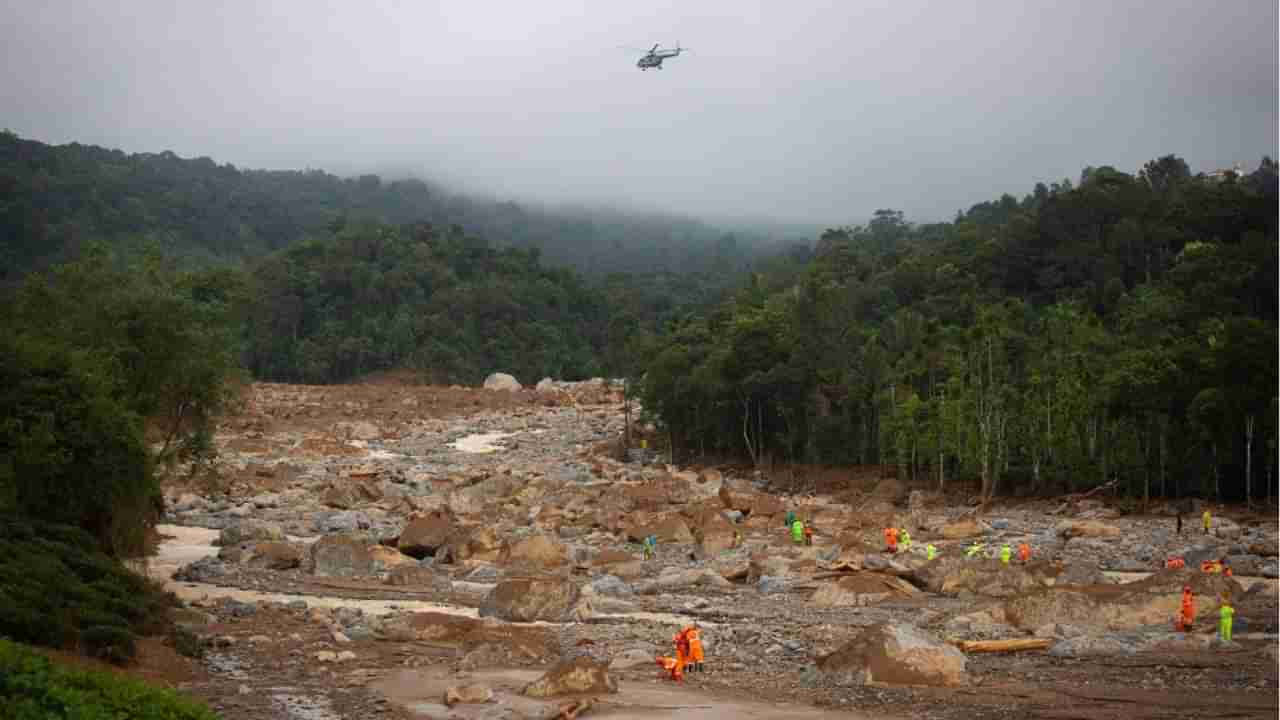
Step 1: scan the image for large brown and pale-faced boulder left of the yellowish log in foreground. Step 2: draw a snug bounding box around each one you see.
[818,623,965,687]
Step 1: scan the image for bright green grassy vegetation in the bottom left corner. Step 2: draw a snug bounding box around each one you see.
[0,639,218,720]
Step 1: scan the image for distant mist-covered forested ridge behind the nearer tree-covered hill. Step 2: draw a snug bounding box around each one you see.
[0,132,773,283]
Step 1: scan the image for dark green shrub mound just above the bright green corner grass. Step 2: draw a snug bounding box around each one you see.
[0,515,173,662]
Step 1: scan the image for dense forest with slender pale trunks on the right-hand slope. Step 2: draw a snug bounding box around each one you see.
[644,156,1277,498]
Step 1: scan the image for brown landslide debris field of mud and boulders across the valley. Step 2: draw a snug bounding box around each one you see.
[152,379,1277,720]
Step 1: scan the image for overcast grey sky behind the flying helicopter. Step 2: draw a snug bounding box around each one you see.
[0,0,1280,224]
